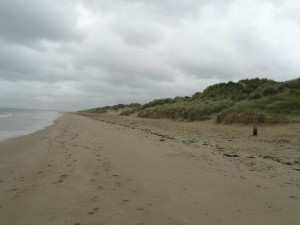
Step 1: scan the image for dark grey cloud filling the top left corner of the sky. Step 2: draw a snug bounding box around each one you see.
[0,0,81,43]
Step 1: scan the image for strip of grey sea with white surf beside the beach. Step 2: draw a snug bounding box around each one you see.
[0,108,62,141]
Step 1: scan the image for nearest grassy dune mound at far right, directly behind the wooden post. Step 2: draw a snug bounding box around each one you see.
[217,79,300,122]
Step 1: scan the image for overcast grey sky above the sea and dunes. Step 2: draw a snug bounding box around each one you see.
[0,0,300,110]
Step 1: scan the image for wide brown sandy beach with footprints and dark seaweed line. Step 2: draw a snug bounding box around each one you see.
[0,114,300,225]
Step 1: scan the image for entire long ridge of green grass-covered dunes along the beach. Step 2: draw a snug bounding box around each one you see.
[78,78,300,123]
